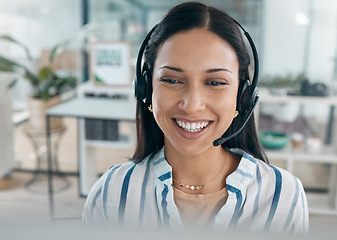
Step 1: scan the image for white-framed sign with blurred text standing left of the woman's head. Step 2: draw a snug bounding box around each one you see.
[90,42,131,85]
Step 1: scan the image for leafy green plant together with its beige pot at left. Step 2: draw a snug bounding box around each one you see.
[0,35,77,132]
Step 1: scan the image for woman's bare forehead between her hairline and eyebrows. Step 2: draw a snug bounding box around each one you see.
[155,28,238,69]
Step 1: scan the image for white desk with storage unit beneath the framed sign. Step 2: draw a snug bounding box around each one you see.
[46,83,136,196]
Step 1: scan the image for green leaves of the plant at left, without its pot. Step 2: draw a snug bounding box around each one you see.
[0,35,77,101]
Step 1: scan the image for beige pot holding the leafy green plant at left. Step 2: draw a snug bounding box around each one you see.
[28,96,63,133]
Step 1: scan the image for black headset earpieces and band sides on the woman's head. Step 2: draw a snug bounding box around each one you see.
[133,19,259,114]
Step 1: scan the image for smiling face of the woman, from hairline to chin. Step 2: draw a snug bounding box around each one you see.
[152,28,239,157]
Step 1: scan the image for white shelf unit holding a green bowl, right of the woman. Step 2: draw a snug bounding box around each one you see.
[255,89,337,215]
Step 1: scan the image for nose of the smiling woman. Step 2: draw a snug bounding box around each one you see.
[179,86,206,114]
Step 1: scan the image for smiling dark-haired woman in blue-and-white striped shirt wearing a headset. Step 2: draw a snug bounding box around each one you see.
[83,2,308,233]
